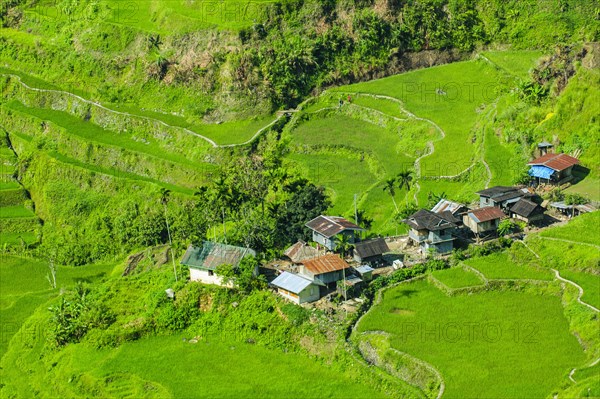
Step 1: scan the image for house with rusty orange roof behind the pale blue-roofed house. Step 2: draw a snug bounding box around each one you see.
[299,254,350,293]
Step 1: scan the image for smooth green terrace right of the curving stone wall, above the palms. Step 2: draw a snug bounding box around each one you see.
[340,61,506,176]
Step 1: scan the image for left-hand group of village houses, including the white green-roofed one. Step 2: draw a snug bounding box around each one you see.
[181,215,390,304]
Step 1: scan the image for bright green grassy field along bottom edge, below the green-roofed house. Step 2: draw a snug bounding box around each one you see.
[54,335,392,398]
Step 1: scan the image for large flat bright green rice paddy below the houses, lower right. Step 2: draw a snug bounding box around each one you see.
[359,281,585,399]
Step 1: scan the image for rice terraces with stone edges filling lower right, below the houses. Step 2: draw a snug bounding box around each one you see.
[353,212,600,398]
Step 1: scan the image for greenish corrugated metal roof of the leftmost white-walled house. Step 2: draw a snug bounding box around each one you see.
[181,241,256,270]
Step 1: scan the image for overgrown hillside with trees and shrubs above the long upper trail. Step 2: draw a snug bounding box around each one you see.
[0,0,599,121]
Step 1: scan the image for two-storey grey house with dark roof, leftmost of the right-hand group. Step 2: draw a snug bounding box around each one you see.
[403,209,456,254]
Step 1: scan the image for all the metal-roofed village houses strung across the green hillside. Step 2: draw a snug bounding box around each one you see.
[181,149,592,304]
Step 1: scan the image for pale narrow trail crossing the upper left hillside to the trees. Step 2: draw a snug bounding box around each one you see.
[0,73,284,148]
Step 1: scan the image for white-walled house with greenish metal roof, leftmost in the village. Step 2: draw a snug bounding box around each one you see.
[181,241,258,287]
